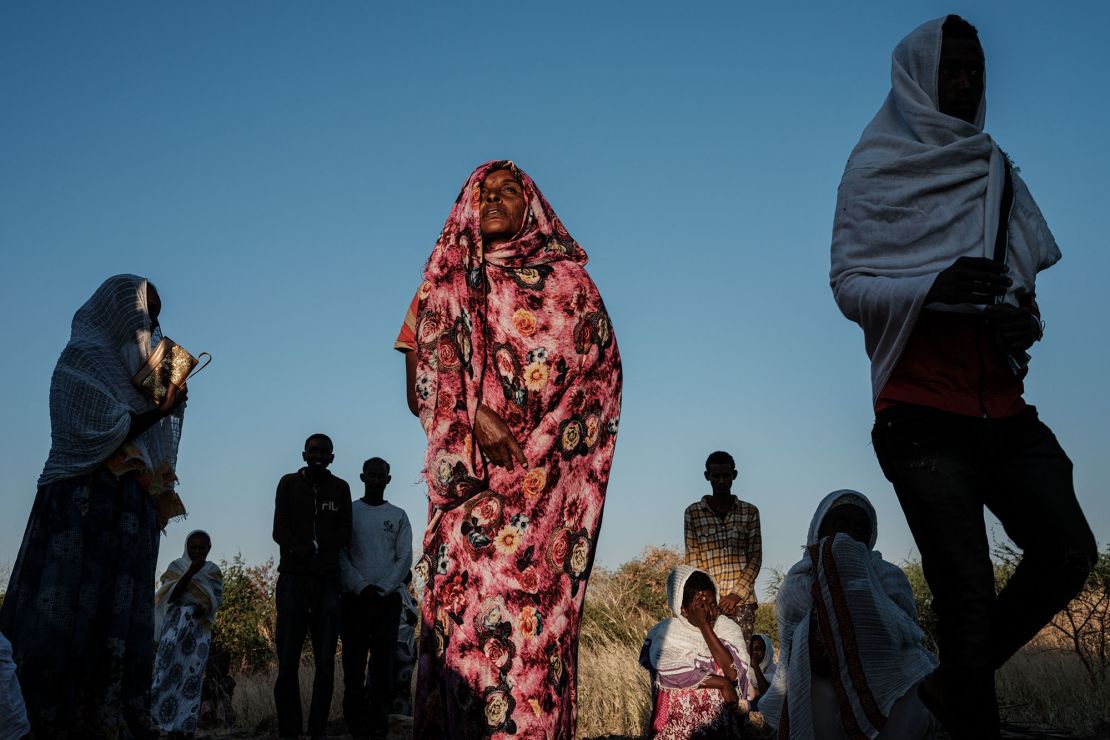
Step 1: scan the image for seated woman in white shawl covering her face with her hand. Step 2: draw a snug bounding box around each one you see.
[639,565,749,740]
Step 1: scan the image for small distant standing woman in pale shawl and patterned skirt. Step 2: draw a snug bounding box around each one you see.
[151,529,223,737]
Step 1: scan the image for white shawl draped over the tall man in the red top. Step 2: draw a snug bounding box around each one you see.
[829,17,1060,398]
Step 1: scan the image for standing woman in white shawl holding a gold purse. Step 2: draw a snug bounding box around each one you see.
[0,275,185,738]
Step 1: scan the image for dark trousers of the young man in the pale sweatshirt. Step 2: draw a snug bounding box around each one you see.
[342,589,401,737]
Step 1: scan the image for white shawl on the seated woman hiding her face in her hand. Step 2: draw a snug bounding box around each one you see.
[640,565,751,698]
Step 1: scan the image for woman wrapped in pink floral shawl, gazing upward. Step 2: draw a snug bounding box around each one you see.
[398,161,622,739]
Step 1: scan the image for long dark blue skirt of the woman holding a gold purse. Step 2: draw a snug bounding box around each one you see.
[0,468,159,740]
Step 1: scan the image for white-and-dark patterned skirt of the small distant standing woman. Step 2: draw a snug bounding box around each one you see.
[150,604,212,732]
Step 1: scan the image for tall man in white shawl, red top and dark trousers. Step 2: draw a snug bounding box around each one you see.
[830,16,1097,739]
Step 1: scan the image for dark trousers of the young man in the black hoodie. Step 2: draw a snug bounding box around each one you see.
[274,572,340,738]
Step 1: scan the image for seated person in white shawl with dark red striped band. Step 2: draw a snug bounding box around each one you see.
[759,490,937,740]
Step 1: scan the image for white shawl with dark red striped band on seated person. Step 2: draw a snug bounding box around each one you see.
[759,489,937,740]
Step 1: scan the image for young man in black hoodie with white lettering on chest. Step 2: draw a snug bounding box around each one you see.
[274,434,351,738]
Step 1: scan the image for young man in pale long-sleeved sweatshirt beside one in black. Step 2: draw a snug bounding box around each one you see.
[340,457,413,738]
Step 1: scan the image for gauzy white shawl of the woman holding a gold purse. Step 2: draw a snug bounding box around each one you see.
[39,275,184,486]
